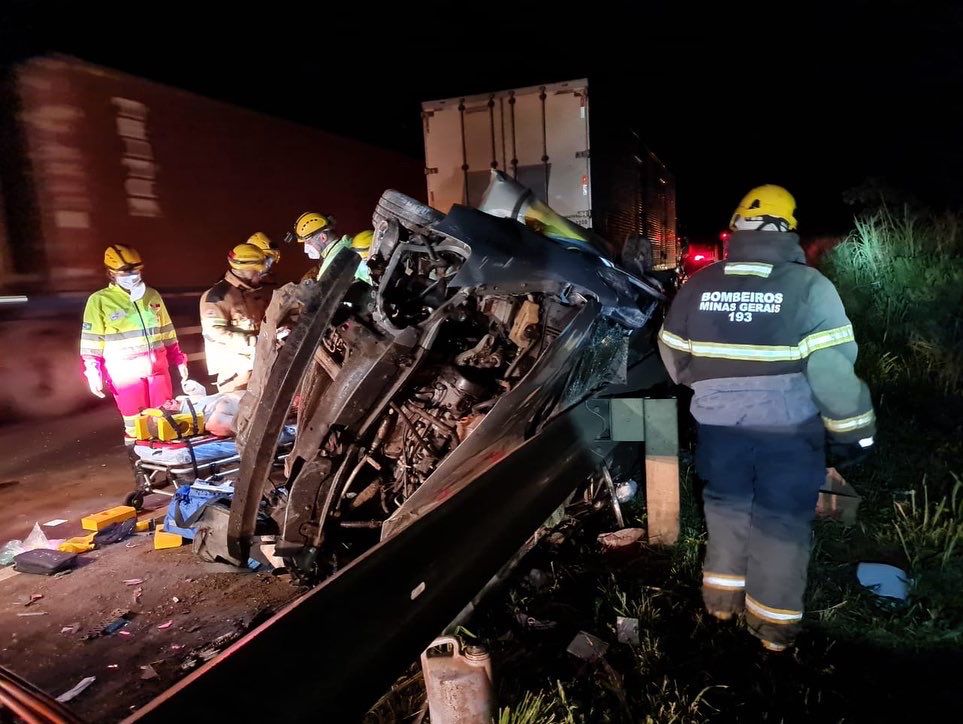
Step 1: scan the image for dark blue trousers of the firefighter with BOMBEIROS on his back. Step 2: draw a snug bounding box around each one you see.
[696,418,826,644]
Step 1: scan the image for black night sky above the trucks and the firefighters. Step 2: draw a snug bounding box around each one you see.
[0,0,963,237]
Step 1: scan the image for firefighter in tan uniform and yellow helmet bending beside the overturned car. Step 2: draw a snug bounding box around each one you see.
[200,244,271,392]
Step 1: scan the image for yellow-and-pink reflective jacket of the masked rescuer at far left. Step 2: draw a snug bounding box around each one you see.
[80,283,187,384]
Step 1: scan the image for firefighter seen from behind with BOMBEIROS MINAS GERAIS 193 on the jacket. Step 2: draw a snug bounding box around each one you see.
[659,185,875,651]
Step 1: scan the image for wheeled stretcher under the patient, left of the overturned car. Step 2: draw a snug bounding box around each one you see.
[124,426,294,510]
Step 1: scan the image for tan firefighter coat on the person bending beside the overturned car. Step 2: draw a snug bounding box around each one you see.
[200,271,273,389]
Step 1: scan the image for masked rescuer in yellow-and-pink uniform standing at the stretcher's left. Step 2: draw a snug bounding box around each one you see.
[80,244,188,438]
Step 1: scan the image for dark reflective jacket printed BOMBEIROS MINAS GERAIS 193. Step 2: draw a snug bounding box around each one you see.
[659,231,876,442]
